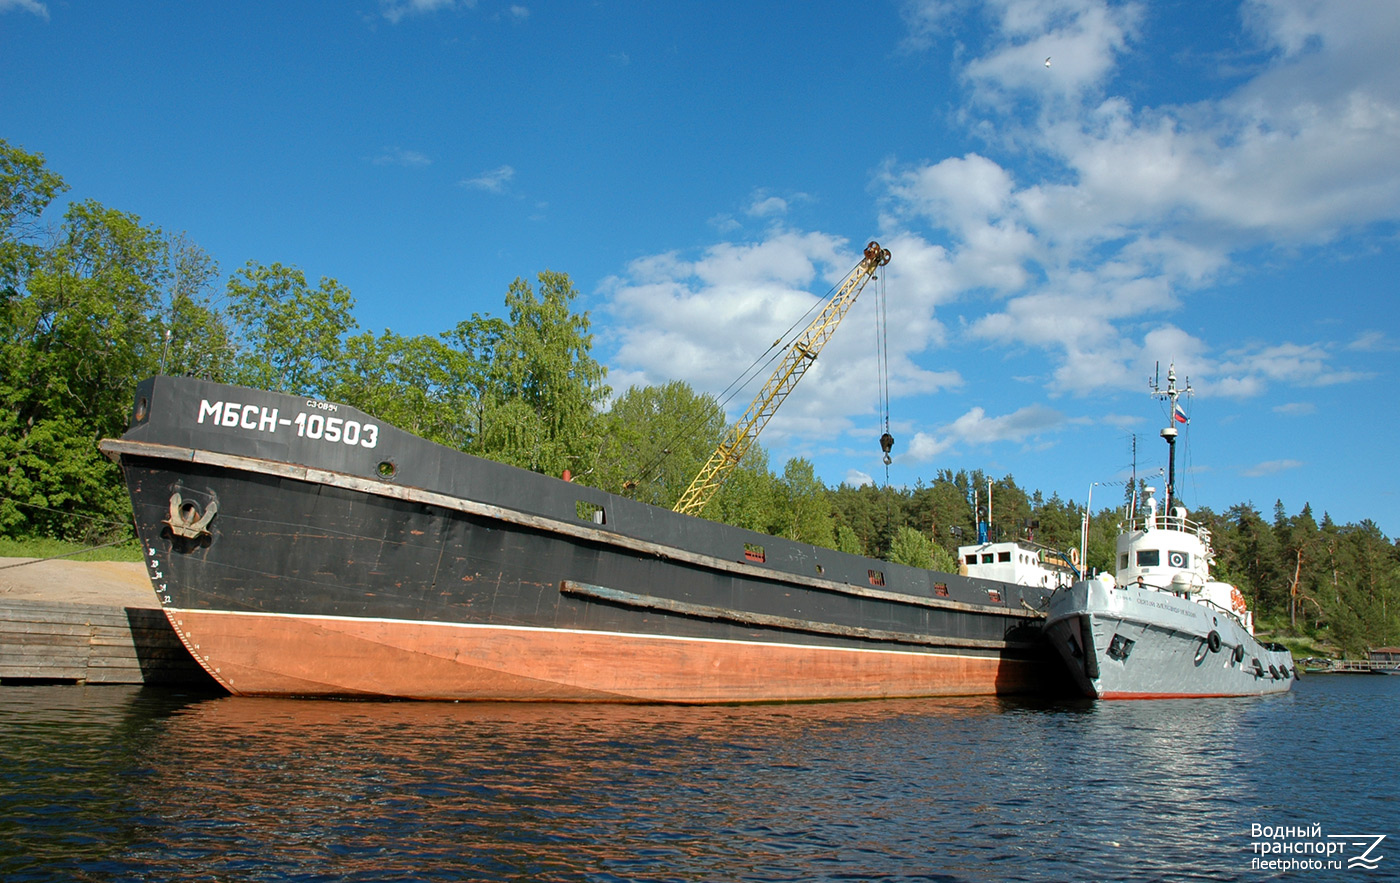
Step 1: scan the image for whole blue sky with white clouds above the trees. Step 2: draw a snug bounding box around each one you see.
[0,0,1400,537]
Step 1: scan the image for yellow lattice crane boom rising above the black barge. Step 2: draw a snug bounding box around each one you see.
[675,241,889,515]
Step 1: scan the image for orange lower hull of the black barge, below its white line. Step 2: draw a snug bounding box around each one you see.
[167,610,1043,704]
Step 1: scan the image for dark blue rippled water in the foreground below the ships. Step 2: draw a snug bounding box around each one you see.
[0,679,1400,880]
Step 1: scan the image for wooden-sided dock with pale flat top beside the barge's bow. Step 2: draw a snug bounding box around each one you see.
[0,558,220,690]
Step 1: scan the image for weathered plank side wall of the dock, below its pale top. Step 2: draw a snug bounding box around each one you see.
[0,600,217,688]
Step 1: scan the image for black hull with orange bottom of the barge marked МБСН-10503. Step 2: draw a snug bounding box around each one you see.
[104,378,1054,701]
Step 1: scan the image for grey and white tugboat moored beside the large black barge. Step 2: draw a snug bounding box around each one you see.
[1044,365,1298,700]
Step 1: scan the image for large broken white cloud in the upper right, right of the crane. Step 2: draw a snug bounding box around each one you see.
[881,0,1400,396]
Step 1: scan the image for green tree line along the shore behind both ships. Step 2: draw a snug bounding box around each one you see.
[0,140,1400,652]
